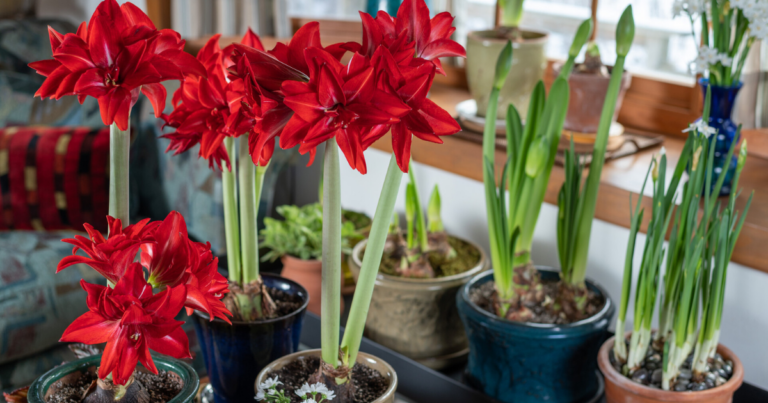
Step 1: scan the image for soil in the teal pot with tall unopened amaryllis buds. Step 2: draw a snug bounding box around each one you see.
[469,279,605,325]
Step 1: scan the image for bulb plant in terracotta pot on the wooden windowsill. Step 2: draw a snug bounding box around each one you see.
[554,0,632,143]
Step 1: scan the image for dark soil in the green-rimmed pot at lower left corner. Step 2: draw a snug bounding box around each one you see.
[45,370,184,403]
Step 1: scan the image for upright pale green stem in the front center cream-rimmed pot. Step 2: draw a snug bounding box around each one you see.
[320,138,340,368]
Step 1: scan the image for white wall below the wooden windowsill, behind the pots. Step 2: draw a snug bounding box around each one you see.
[340,149,768,389]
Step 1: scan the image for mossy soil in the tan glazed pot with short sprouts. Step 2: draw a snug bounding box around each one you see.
[374,236,480,278]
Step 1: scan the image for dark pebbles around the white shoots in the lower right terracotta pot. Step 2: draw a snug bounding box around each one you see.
[608,340,733,392]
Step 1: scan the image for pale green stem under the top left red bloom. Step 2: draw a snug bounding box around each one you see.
[109,122,131,227]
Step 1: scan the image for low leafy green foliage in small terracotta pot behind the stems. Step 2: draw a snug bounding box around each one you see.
[261,203,362,261]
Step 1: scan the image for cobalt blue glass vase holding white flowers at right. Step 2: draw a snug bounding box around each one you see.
[699,78,742,196]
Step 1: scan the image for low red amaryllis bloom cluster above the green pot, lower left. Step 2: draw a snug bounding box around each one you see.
[57,211,231,385]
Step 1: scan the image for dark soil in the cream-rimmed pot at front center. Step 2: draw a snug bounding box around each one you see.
[267,357,389,403]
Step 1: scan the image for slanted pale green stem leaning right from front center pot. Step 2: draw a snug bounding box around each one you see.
[341,154,403,367]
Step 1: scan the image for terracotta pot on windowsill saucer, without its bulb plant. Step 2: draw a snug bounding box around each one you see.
[553,64,632,134]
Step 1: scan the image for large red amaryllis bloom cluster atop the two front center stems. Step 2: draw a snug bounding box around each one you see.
[164,0,465,173]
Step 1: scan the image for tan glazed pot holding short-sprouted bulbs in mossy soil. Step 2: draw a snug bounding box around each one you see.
[349,240,488,369]
